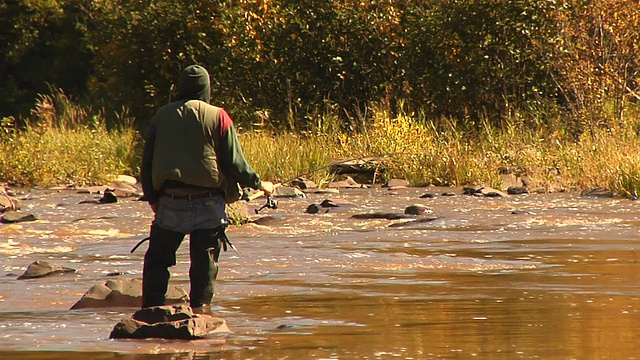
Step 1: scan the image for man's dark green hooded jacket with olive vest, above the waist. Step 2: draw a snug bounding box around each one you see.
[140,65,260,204]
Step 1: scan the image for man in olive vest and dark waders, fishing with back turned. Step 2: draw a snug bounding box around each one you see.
[140,65,273,311]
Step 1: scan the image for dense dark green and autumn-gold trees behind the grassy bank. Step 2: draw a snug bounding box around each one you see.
[0,0,640,137]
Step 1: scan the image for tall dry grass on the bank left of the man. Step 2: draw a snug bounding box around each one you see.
[0,91,139,187]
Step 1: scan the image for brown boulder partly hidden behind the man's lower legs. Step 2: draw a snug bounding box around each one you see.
[70,278,189,310]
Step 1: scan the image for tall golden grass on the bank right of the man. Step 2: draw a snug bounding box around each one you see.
[241,102,640,196]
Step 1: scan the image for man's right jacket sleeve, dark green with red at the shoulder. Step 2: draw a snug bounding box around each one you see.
[216,110,261,189]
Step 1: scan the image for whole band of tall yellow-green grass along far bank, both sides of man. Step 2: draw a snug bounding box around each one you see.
[0,92,640,196]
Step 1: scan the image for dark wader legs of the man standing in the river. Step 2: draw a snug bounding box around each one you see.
[142,224,224,308]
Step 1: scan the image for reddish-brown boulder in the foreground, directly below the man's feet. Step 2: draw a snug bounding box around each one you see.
[109,305,231,340]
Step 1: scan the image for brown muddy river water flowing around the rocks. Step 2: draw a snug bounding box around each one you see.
[0,187,640,360]
